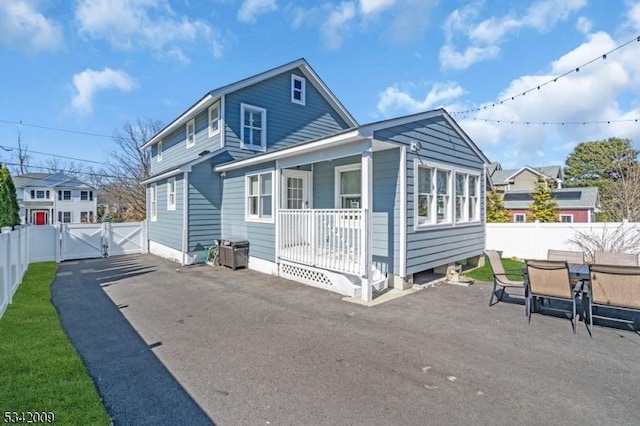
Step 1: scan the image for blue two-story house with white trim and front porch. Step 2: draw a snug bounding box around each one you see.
[143,59,488,300]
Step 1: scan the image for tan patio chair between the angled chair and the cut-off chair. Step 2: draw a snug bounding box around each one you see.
[525,260,580,333]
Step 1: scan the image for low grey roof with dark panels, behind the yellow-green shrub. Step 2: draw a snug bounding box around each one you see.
[504,186,598,209]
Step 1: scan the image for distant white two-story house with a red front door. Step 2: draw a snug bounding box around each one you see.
[13,173,97,225]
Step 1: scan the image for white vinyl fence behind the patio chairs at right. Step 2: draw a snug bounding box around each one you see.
[486,222,640,259]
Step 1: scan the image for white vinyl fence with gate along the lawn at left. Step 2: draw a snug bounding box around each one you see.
[0,222,148,318]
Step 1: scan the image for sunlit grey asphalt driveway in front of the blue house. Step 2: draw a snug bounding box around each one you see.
[53,255,640,425]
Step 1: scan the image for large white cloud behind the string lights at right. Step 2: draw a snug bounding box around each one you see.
[450,32,640,168]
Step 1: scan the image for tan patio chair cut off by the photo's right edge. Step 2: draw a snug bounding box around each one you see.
[589,264,640,333]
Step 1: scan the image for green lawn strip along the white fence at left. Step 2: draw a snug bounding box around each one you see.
[0,262,110,425]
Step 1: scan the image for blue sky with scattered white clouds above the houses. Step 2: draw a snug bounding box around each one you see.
[0,0,640,171]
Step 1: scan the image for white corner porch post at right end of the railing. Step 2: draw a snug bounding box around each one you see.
[360,144,373,302]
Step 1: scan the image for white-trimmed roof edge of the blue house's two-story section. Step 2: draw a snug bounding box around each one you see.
[140,58,358,149]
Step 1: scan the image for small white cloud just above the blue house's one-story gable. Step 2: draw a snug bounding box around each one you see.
[377,82,465,117]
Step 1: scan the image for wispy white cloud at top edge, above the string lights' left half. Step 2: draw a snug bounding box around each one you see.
[440,0,586,69]
